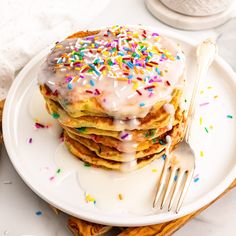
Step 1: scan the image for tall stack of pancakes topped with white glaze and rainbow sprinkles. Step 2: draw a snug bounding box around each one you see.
[39,26,184,171]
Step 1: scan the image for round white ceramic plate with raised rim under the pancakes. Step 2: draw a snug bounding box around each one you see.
[3,28,236,226]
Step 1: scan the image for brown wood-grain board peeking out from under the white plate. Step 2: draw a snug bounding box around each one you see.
[0,101,236,236]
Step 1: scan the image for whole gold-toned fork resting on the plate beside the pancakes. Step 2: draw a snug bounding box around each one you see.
[153,39,217,213]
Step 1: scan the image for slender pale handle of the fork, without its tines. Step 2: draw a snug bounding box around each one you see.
[184,38,217,143]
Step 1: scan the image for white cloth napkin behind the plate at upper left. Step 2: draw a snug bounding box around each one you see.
[0,0,110,100]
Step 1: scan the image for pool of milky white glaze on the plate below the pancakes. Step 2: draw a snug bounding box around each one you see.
[54,143,163,214]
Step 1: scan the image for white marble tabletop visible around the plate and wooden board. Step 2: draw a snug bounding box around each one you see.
[0,0,236,236]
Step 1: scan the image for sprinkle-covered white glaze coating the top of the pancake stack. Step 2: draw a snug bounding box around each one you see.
[39,27,184,119]
